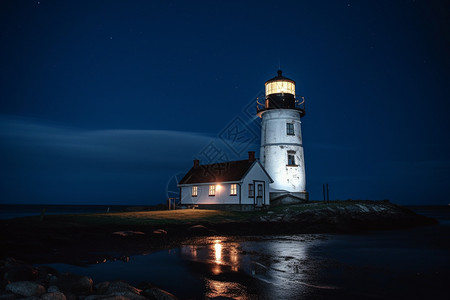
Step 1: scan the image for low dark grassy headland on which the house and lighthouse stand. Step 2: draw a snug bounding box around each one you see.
[0,201,437,264]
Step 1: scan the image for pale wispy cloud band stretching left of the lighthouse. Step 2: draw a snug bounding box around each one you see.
[0,117,213,168]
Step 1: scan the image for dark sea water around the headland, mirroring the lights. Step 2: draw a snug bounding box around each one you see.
[0,206,450,299]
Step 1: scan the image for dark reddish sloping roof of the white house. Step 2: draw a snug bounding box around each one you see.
[178,159,257,184]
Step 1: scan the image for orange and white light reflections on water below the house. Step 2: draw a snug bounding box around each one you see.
[180,235,320,299]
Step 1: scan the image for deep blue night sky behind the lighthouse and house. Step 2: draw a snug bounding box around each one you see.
[0,0,450,204]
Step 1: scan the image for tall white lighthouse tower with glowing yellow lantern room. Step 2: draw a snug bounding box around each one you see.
[257,70,308,203]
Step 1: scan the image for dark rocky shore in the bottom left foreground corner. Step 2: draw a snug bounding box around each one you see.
[0,258,177,300]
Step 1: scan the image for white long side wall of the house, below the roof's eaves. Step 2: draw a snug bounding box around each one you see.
[181,183,240,205]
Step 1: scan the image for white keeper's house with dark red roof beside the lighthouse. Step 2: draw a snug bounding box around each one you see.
[178,151,273,210]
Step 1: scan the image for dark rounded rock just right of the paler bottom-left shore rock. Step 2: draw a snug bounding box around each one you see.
[49,273,93,294]
